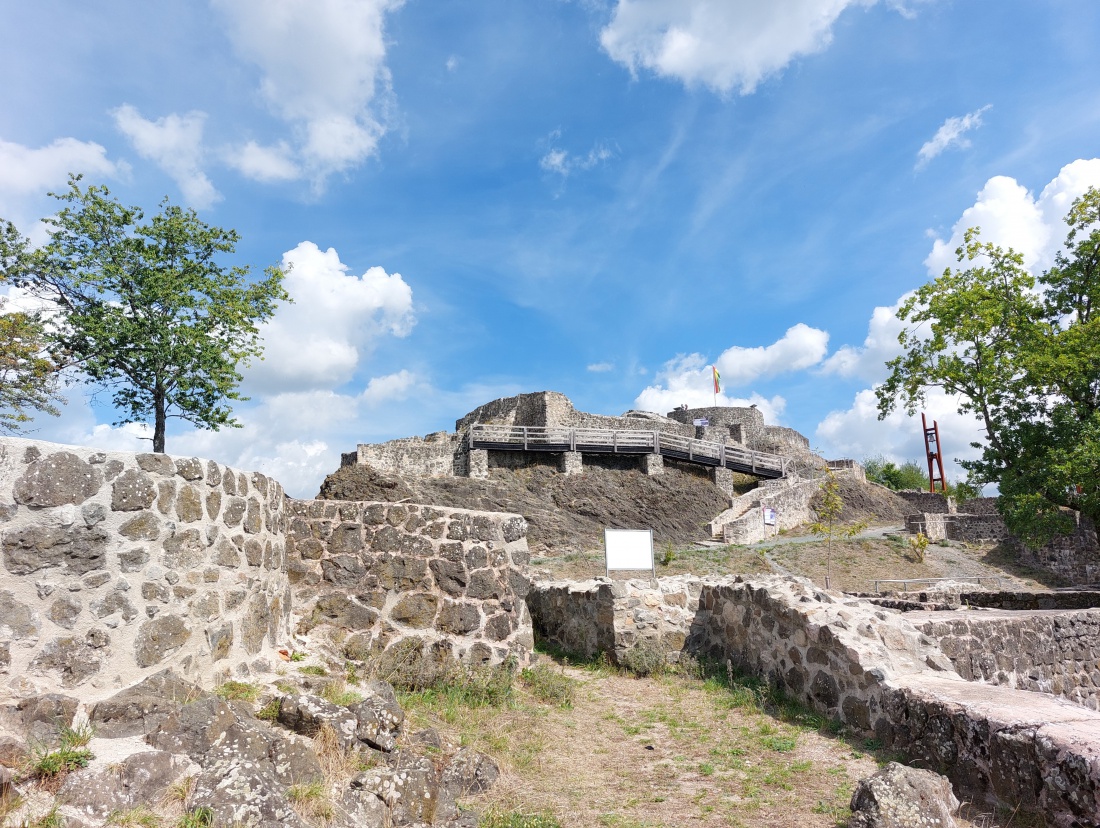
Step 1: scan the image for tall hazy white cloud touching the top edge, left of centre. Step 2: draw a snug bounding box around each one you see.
[212,0,404,184]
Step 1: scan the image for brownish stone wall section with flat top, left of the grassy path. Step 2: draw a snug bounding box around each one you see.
[287,500,532,684]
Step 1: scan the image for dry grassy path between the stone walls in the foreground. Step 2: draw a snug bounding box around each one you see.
[403,650,1022,828]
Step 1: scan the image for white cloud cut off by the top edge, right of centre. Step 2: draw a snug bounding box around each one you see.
[600,0,876,95]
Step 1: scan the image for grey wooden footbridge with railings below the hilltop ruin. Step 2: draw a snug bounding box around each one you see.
[470,423,788,479]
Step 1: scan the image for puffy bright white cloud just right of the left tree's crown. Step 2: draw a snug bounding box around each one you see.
[246,242,415,391]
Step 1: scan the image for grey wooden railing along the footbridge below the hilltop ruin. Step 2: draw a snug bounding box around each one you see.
[470,422,789,475]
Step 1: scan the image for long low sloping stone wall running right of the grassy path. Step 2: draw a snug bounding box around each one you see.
[530,577,1100,828]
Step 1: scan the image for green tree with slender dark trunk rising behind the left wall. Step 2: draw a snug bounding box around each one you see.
[0,176,288,452]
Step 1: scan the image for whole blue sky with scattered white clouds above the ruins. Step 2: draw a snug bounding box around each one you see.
[0,0,1100,496]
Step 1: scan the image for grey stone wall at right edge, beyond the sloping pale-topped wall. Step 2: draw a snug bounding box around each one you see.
[906,610,1100,710]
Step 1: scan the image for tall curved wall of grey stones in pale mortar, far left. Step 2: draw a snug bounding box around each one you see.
[0,438,290,699]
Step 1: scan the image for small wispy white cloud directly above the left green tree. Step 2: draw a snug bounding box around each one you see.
[112,103,221,209]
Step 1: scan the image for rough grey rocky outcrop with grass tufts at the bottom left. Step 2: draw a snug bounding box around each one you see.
[0,672,498,828]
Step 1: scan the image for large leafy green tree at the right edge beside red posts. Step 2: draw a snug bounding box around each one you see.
[878,189,1100,545]
